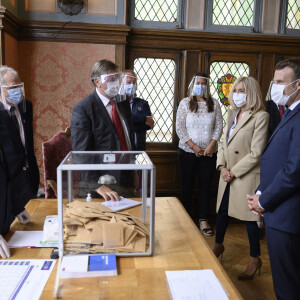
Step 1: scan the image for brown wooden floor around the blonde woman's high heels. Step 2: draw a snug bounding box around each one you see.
[200,223,276,300]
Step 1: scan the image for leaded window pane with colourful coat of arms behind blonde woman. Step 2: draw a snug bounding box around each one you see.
[210,61,250,127]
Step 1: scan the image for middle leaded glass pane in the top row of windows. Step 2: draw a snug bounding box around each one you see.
[212,0,255,26]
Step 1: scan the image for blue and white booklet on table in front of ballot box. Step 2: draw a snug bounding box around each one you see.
[60,254,118,278]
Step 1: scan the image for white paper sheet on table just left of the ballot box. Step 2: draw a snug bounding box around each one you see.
[8,231,58,248]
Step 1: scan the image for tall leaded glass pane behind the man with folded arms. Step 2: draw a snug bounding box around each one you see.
[134,58,176,143]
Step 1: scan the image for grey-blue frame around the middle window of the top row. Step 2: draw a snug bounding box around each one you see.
[205,0,263,34]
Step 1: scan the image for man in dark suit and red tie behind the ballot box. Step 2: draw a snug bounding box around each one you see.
[70,59,134,200]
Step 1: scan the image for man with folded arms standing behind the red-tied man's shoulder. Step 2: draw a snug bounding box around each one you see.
[120,70,154,151]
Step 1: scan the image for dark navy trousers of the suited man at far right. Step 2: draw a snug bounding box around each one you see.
[266,225,300,300]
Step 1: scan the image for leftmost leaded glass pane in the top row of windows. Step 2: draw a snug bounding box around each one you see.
[134,0,178,22]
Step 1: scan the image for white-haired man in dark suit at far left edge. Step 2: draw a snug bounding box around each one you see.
[0,66,40,258]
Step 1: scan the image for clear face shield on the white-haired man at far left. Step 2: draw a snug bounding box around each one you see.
[1,82,26,111]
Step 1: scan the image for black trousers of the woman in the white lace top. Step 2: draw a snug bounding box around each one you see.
[178,148,217,219]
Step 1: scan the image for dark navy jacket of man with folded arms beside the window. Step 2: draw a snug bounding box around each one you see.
[131,97,152,150]
